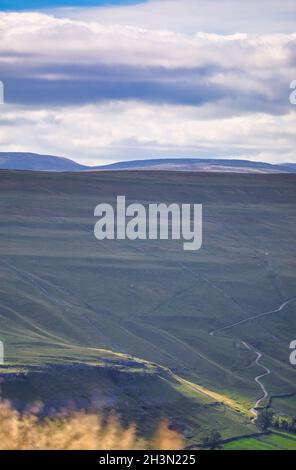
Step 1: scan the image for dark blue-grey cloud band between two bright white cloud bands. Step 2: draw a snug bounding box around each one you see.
[1,64,290,114]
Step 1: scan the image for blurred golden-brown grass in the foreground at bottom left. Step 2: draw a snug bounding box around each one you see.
[0,402,184,450]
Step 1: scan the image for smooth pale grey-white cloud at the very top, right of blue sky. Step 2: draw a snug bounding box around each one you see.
[55,0,296,34]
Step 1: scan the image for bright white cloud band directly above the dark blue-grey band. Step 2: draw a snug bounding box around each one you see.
[0,13,296,72]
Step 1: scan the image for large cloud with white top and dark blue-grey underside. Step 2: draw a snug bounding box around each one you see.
[0,11,296,114]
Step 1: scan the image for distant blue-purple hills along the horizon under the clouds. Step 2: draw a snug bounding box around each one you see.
[0,152,296,173]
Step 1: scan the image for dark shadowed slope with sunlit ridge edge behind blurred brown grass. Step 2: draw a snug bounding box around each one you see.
[2,362,254,445]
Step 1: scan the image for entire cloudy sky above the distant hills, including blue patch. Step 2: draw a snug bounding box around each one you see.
[0,0,296,165]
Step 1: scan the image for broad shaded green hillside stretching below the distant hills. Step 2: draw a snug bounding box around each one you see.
[0,171,296,438]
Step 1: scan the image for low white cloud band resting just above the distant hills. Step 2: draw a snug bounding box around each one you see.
[0,101,295,165]
